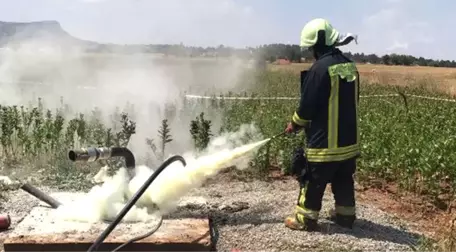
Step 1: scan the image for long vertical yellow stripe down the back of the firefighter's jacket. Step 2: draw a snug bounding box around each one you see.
[328,75,339,149]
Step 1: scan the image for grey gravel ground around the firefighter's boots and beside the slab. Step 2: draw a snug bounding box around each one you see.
[0,177,428,252]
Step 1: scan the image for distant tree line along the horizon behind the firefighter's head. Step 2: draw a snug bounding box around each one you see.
[89,43,456,67]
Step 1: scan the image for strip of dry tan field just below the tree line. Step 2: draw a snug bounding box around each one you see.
[269,63,456,95]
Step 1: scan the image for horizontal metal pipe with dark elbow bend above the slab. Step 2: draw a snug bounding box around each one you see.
[68,147,135,169]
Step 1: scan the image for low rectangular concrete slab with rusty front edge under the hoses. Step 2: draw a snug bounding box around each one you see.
[4,193,211,252]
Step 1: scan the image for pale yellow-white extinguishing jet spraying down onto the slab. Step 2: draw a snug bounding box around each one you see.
[57,139,270,222]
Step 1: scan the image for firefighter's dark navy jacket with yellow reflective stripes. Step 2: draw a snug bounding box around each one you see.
[292,49,360,162]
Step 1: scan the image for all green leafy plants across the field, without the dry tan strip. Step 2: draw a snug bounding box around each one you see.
[0,69,456,207]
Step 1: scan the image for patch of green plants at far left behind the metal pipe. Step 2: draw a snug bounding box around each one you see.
[0,99,136,189]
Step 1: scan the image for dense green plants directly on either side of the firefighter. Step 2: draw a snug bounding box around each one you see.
[216,72,456,206]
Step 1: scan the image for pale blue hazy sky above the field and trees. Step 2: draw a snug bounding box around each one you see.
[0,0,456,60]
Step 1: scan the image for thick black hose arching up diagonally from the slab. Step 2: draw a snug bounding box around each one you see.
[87,155,187,252]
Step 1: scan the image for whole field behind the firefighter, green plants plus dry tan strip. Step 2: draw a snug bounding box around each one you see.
[0,59,456,250]
